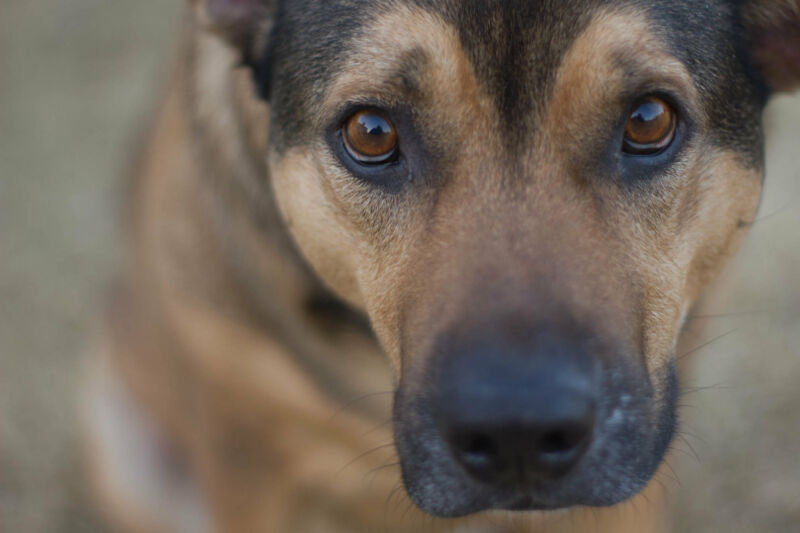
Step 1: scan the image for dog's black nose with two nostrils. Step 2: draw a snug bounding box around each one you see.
[436,338,595,485]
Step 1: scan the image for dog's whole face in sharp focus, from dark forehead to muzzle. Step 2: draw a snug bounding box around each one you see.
[197,0,800,516]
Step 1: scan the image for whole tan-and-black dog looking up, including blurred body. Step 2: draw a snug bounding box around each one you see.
[85,0,800,533]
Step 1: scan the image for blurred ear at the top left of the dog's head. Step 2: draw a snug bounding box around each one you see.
[191,0,278,50]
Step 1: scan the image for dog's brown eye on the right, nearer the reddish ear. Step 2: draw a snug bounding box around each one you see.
[622,96,677,155]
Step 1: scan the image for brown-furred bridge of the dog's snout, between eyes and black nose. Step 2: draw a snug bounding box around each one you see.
[403,154,637,362]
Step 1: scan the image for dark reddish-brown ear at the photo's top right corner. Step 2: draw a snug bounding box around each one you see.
[742,0,800,91]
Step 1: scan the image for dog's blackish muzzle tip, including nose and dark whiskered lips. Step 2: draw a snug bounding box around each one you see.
[395,324,675,517]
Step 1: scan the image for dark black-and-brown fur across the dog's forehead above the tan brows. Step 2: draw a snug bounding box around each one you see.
[274,0,760,160]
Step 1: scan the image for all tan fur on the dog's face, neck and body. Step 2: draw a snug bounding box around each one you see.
[87,7,760,533]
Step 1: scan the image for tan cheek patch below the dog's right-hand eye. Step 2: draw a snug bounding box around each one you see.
[617,149,762,371]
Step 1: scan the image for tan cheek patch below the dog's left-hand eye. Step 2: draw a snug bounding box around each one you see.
[268,146,420,373]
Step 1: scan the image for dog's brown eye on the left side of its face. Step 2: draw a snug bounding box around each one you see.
[342,109,397,164]
